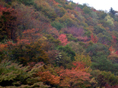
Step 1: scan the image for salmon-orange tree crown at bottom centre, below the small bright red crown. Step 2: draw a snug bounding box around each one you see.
[59,69,90,87]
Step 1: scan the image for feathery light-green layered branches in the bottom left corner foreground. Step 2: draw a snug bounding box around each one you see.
[0,60,48,88]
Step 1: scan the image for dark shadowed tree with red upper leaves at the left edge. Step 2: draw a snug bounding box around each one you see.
[0,6,17,41]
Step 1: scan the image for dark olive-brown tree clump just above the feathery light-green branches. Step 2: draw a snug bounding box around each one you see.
[10,42,48,65]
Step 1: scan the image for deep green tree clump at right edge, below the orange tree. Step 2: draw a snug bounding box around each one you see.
[91,55,118,74]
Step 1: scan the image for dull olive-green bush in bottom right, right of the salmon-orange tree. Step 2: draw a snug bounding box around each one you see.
[91,70,118,87]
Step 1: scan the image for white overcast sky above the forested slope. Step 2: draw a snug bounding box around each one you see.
[72,0,118,11]
